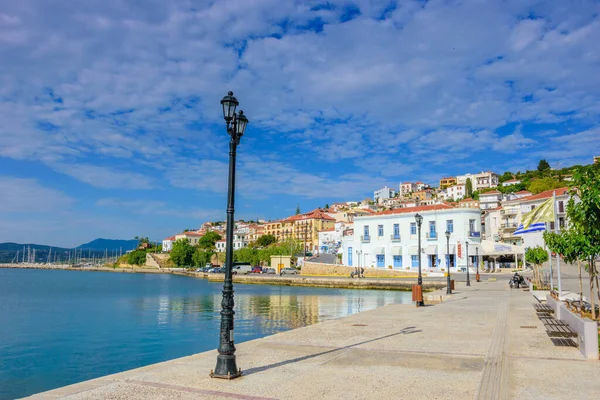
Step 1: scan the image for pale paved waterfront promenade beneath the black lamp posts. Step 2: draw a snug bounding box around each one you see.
[27,279,600,399]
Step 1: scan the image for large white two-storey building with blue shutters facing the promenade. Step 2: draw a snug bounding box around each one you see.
[342,204,483,272]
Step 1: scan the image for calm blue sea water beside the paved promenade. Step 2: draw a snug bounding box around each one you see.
[0,269,411,399]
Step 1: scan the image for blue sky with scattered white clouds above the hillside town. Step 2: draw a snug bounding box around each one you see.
[0,0,600,246]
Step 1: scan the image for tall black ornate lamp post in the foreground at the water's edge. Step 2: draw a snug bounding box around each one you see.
[210,92,248,379]
